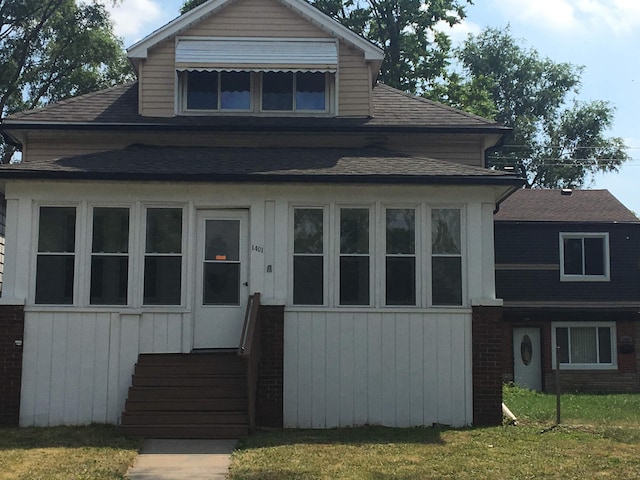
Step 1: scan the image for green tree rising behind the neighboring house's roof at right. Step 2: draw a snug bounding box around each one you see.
[429,28,629,188]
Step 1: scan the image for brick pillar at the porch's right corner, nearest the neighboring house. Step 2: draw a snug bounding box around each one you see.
[472,307,505,426]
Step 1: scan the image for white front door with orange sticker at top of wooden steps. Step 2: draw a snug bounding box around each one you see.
[193,210,249,348]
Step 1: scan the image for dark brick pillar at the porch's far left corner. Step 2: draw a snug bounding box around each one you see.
[0,305,24,426]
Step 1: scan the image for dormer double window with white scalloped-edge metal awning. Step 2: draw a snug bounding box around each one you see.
[176,37,338,115]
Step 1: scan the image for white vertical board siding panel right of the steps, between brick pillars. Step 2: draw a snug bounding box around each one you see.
[284,310,473,428]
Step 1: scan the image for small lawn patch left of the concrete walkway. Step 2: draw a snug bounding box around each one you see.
[0,425,141,480]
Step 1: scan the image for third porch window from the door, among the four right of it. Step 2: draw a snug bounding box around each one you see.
[385,208,416,305]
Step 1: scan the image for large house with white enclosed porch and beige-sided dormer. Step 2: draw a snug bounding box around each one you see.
[0,0,522,436]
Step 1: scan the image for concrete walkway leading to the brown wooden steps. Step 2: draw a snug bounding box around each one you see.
[127,440,238,480]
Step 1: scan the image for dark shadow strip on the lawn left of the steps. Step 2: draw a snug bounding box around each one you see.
[0,424,142,450]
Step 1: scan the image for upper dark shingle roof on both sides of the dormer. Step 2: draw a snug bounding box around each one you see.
[3,82,508,133]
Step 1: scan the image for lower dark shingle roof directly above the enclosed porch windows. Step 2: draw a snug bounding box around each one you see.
[0,145,522,187]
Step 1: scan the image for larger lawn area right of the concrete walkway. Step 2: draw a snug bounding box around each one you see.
[231,387,640,480]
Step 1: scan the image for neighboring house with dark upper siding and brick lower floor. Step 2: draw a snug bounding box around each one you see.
[494,189,640,392]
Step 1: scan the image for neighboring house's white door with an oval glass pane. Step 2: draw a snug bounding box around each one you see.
[513,327,542,391]
